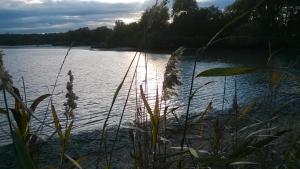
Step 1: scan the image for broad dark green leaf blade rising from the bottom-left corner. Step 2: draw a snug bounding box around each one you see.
[12,131,35,169]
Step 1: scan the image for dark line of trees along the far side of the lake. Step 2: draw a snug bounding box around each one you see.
[0,0,300,50]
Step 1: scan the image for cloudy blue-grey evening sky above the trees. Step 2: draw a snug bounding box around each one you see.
[0,0,234,34]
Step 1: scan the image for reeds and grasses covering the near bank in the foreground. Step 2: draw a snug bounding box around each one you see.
[0,0,300,169]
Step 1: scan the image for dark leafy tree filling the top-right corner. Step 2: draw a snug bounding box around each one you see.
[224,0,300,45]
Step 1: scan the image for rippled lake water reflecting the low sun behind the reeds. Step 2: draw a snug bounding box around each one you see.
[0,47,300,144]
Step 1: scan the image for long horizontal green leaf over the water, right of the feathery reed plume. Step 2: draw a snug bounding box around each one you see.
[196,67,257,77]
